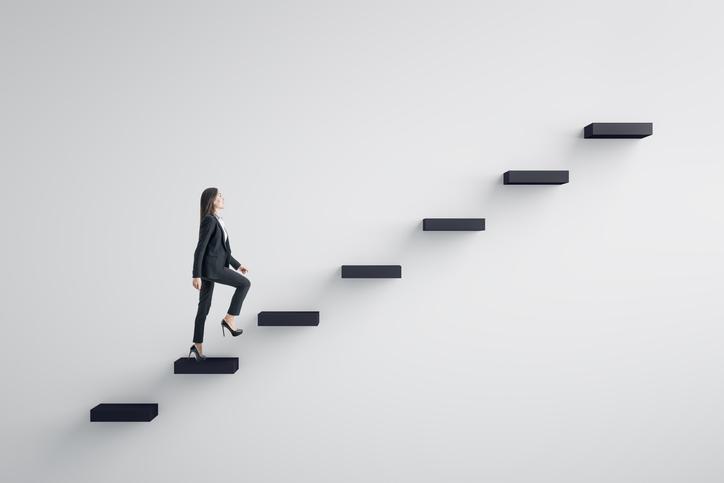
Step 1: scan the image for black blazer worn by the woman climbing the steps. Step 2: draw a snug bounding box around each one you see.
[192,214,241,278]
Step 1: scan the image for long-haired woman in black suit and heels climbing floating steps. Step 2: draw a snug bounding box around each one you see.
[189,188,251,361]
